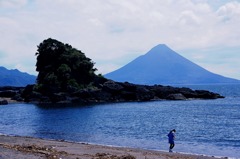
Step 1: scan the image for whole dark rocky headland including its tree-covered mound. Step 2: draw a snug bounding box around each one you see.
[0,39,223,104]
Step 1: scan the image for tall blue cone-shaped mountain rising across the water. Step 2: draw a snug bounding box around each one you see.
[105,44,240,85]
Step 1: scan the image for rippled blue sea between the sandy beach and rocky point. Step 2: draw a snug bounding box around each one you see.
[0,84,240,158]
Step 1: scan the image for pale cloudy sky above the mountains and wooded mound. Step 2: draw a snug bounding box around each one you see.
[0,0,240,79]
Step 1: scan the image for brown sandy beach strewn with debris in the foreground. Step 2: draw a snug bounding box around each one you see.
[0,134,227,159]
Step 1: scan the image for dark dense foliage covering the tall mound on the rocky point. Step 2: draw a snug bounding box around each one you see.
[36,38,99,91]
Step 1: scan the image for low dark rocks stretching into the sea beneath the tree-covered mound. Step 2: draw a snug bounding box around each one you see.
[0,80,224,105]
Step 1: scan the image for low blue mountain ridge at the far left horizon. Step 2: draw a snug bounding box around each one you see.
[0,66,36,87]
